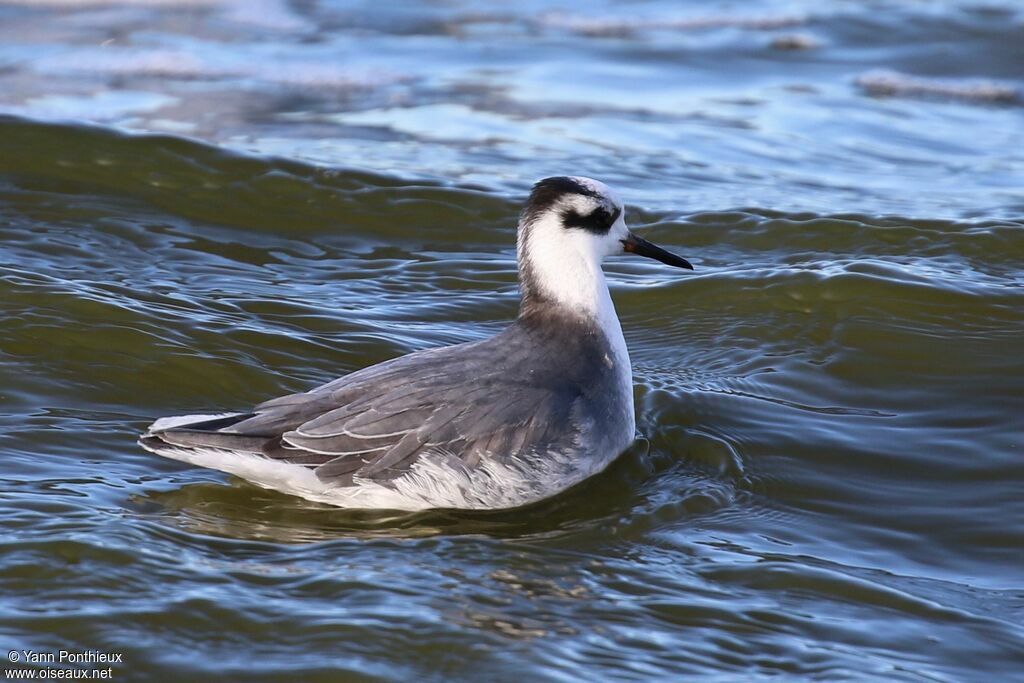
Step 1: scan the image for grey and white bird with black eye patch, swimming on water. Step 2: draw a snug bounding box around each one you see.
[139,176,693,510]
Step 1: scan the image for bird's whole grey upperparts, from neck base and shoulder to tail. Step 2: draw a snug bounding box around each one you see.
[150,312,624,486]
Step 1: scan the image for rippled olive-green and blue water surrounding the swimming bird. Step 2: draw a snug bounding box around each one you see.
[0,0,1024,681]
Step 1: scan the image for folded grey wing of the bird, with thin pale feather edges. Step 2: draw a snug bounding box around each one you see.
[162,342,581,485]
